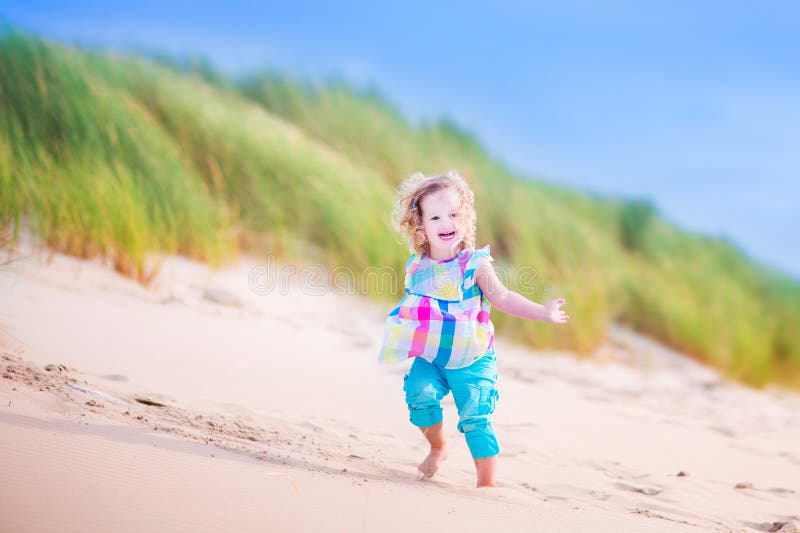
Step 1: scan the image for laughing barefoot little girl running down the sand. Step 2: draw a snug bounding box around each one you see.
[380,170,569,487]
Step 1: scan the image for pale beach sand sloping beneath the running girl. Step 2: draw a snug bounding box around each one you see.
[0,243,800,532]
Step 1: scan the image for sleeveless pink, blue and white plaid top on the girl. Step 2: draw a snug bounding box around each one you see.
[380,245,494,368]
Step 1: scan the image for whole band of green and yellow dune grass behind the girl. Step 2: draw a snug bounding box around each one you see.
[0,32,800,386]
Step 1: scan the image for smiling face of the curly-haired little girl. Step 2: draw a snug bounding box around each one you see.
[420,188,464,261]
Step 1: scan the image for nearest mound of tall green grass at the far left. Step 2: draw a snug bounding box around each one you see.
[0,30,232,281]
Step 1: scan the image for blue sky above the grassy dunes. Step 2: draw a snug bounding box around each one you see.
[0,0,800,278]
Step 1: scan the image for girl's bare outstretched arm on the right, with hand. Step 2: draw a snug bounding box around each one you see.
[475,259,569,324]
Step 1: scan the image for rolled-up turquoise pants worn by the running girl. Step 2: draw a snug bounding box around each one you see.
[403,346,500,459]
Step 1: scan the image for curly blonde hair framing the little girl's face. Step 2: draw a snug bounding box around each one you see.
[392,170,478,255]
